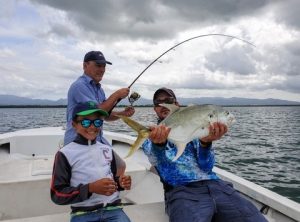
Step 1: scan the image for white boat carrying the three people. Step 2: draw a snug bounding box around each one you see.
[0,127,300,222]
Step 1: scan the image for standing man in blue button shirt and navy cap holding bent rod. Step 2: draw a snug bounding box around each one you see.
[64,51,135,175]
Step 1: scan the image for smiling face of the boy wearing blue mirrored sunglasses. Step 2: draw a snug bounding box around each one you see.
[73,113,103,140]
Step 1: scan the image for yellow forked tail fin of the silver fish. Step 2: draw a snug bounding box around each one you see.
[116,115,150,158]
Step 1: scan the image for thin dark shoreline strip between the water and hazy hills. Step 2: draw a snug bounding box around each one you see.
[0,104,300,109]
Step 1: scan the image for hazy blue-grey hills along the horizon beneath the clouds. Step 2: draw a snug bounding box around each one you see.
[0,95,300,106]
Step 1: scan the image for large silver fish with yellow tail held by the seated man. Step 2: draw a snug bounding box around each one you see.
[119,104,235,161]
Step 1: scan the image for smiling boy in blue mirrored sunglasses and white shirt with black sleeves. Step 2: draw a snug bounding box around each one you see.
[51,102,131,222]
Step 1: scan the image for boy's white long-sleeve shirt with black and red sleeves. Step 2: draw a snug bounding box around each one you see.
[51,137,119,208]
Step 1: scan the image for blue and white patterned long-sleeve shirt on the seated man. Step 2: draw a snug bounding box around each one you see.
[142,139,219,186]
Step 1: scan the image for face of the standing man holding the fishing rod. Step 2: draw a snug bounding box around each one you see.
[83,61,106,83]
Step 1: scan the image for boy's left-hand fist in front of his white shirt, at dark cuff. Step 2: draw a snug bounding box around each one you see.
[89,178,118,196]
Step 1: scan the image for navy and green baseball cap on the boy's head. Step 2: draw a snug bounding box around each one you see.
[72,101,109,120]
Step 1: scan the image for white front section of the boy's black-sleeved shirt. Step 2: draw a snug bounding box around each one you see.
[52,141,119,207]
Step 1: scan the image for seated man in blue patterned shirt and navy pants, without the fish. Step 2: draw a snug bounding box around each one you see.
[142,88,267,222]
